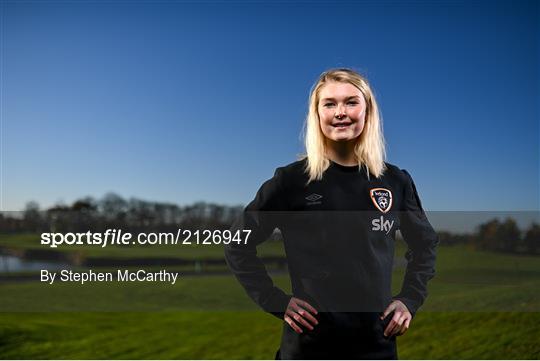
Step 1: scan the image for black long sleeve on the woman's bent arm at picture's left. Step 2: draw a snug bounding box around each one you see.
[225,168,291,318]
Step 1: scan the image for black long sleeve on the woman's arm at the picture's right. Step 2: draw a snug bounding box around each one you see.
[394,170,439,316]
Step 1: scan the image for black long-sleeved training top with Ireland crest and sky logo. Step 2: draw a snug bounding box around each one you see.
[225,159,438,318]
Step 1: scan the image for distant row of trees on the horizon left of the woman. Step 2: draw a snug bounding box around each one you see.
[0,193,243,233]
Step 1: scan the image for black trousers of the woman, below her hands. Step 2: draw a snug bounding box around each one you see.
[275,312,398,360]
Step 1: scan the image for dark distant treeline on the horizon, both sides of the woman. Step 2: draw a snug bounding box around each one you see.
[0,193,540,254]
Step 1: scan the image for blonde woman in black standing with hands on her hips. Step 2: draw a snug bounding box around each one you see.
[225,69,438,359]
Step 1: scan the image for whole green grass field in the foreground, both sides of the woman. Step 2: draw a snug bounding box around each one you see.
[0,238,540,359]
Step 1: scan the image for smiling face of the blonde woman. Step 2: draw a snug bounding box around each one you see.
[318,82,366,142]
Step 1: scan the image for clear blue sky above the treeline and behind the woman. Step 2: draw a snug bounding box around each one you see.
[0,1,540,211]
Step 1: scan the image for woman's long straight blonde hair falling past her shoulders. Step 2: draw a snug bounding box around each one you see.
[301,68,386,184]
